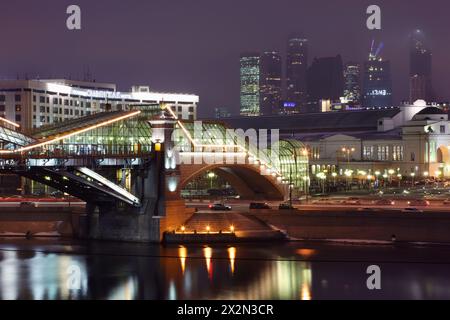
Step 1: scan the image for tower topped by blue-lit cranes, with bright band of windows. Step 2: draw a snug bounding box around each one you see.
[363,42,392,108]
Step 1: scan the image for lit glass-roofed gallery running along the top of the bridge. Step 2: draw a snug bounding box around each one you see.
[0,105,308,200]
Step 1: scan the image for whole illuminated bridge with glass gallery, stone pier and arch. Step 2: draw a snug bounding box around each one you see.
[0,105,308,241]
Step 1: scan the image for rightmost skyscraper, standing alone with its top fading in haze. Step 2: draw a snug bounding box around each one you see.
[409,30,433,103]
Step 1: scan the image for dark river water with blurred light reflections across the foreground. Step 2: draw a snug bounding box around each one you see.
[0,238,450,300]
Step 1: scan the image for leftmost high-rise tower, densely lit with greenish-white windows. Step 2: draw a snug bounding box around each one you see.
[240,53,261,116]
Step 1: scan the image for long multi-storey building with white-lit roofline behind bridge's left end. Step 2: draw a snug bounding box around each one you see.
[0,79,199,131]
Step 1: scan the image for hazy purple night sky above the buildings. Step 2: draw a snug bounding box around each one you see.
[0,0,450,116]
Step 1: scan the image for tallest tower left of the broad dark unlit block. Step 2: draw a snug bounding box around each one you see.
[286,36,308,112]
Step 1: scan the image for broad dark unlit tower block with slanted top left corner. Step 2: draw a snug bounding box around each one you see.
[307,55,344,104]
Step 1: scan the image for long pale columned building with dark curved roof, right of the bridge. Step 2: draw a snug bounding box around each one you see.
[225,100,450,178]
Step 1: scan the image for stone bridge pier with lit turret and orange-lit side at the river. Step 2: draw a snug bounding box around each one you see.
[79,114,194,242]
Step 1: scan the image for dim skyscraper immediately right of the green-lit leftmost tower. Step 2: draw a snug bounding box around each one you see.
[260,51,282,115]
